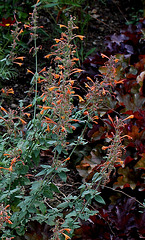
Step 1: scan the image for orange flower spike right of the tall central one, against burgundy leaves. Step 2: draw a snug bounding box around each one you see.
[85,54,123,121]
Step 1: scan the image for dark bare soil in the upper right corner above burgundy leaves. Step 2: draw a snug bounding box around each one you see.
[86,0,143,53]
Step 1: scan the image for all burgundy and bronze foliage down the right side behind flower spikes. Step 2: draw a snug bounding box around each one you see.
[75,19,145,240]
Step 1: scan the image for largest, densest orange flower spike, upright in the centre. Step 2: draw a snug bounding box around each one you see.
[40,17,82,146]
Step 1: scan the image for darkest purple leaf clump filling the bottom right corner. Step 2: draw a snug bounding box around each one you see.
[72,197,145,240]
